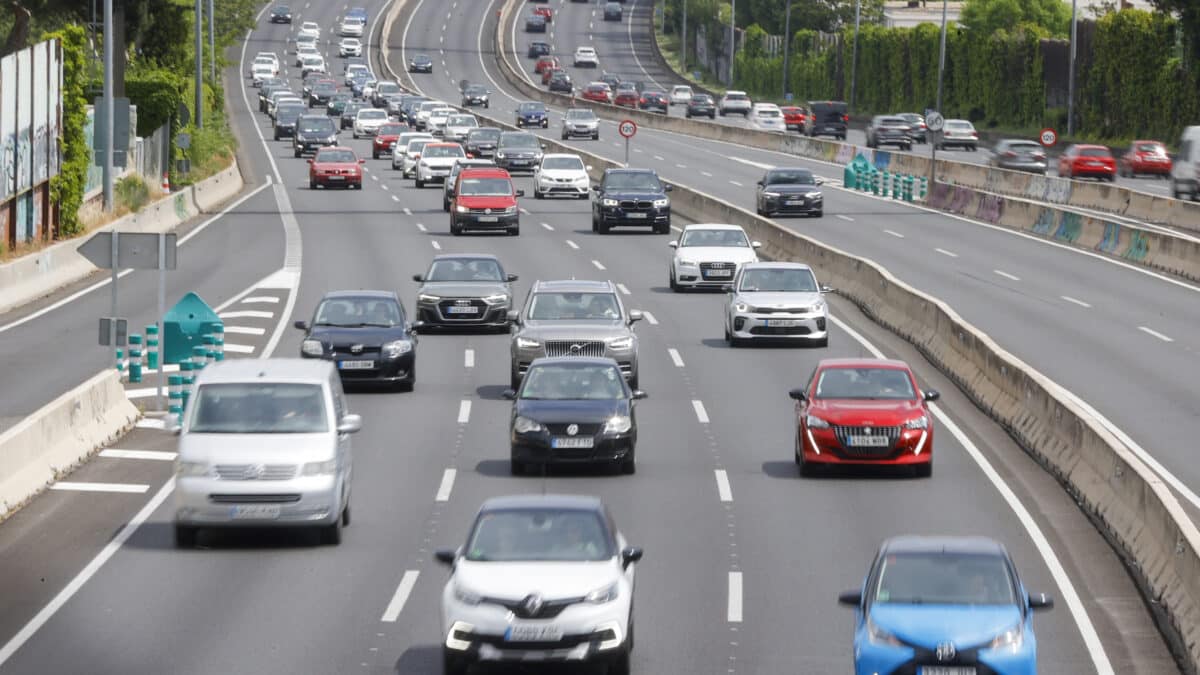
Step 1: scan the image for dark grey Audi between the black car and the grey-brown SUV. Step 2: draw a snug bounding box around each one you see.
[413,253,517,330]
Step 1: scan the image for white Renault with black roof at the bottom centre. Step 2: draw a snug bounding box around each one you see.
[436,495,642,675]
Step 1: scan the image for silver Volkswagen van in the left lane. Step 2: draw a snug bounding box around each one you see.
[174,359,362,548]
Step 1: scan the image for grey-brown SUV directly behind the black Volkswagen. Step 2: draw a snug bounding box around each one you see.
[509,280,642,389]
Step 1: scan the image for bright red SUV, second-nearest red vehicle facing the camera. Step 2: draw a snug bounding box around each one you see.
[450,167,524,237]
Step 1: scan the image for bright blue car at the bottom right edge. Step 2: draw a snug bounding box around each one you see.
[838,537,1054,675]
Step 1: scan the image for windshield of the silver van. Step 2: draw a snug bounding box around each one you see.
[187,382,329,434]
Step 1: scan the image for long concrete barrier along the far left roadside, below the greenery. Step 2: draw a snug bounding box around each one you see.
[0,161,244,313]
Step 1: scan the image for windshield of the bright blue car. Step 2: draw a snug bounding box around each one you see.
[871,551,1016,605]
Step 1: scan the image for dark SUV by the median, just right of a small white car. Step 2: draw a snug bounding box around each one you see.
[592,169,671,234]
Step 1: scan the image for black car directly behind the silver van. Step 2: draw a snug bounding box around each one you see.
[295,291,420,392]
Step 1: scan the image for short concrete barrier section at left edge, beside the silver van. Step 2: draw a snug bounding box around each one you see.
[0,369,139,520]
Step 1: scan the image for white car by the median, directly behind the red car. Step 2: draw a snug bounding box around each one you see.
[725,262,832,347]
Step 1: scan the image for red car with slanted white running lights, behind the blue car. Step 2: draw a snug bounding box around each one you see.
[788,359,938,477]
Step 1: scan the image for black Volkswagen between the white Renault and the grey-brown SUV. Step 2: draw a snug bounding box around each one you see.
[504,357,646,476]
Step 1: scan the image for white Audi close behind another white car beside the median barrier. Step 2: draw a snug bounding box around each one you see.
[667,223,762,292]
